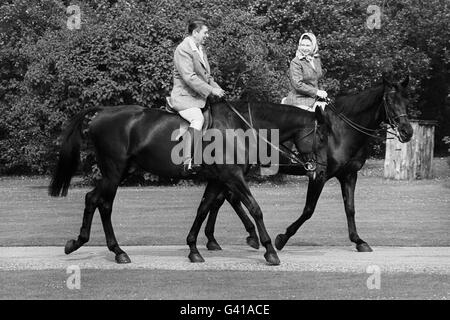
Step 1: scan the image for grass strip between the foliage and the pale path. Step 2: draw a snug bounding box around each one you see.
[0,160,450,246]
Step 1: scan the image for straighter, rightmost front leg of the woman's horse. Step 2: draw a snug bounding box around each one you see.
[338,171,372,252]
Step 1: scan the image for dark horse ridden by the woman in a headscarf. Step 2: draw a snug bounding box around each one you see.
[200,77,413,252]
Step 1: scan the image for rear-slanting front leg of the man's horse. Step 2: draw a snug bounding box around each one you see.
[186,180,224,262]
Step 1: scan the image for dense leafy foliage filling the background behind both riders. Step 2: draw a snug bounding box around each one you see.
[0,0,450,174]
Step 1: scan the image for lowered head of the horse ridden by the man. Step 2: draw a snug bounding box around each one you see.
[294,107,330,179]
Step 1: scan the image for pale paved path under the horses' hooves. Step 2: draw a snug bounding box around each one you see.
[0,246,450,274]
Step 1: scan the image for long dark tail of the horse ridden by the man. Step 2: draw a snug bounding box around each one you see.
[48,107,103,197]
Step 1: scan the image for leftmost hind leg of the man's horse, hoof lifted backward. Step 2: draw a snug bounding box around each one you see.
[64,188,98,254]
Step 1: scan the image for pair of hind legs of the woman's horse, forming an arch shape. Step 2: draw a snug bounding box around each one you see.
[205,191,259,250]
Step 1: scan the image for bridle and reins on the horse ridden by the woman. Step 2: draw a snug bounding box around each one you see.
[325,91,408,140]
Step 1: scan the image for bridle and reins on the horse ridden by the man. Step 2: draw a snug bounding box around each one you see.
[224,100,326,171]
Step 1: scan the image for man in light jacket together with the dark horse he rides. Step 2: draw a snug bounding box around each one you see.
[49,16,329,265]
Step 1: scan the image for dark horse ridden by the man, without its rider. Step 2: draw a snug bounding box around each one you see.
[49,101,328,265]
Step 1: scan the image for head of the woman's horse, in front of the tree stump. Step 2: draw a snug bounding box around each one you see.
[383,76,413,142]
